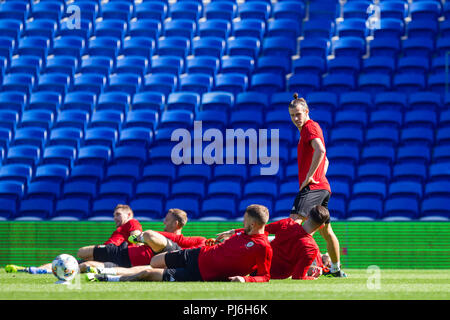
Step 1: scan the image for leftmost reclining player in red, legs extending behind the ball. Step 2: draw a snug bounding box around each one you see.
[5,204,142,274]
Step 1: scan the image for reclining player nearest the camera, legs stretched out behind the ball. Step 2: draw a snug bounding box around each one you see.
[88,205,272,282]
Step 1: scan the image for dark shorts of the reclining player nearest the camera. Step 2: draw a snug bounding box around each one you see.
[163,248,203,281]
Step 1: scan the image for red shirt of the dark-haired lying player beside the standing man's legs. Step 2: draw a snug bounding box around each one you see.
[265,218,320,280]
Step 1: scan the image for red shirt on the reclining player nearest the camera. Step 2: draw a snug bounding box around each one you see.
[198,232,272,282]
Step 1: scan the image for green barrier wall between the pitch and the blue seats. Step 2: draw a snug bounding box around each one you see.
[0,221,450,269]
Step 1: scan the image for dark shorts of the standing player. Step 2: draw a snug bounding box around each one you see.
[291,186,330,224]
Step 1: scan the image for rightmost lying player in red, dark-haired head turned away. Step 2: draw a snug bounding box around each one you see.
[217,205,336,280]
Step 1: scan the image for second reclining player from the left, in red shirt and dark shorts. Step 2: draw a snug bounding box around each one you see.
[80,209,206,274]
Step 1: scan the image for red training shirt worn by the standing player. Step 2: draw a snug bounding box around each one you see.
[297,120,331,193]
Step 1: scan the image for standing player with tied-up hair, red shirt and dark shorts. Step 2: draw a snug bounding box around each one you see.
[289,93,346,277]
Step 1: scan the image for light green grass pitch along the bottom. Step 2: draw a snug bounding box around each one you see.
[0,269,450,300]
